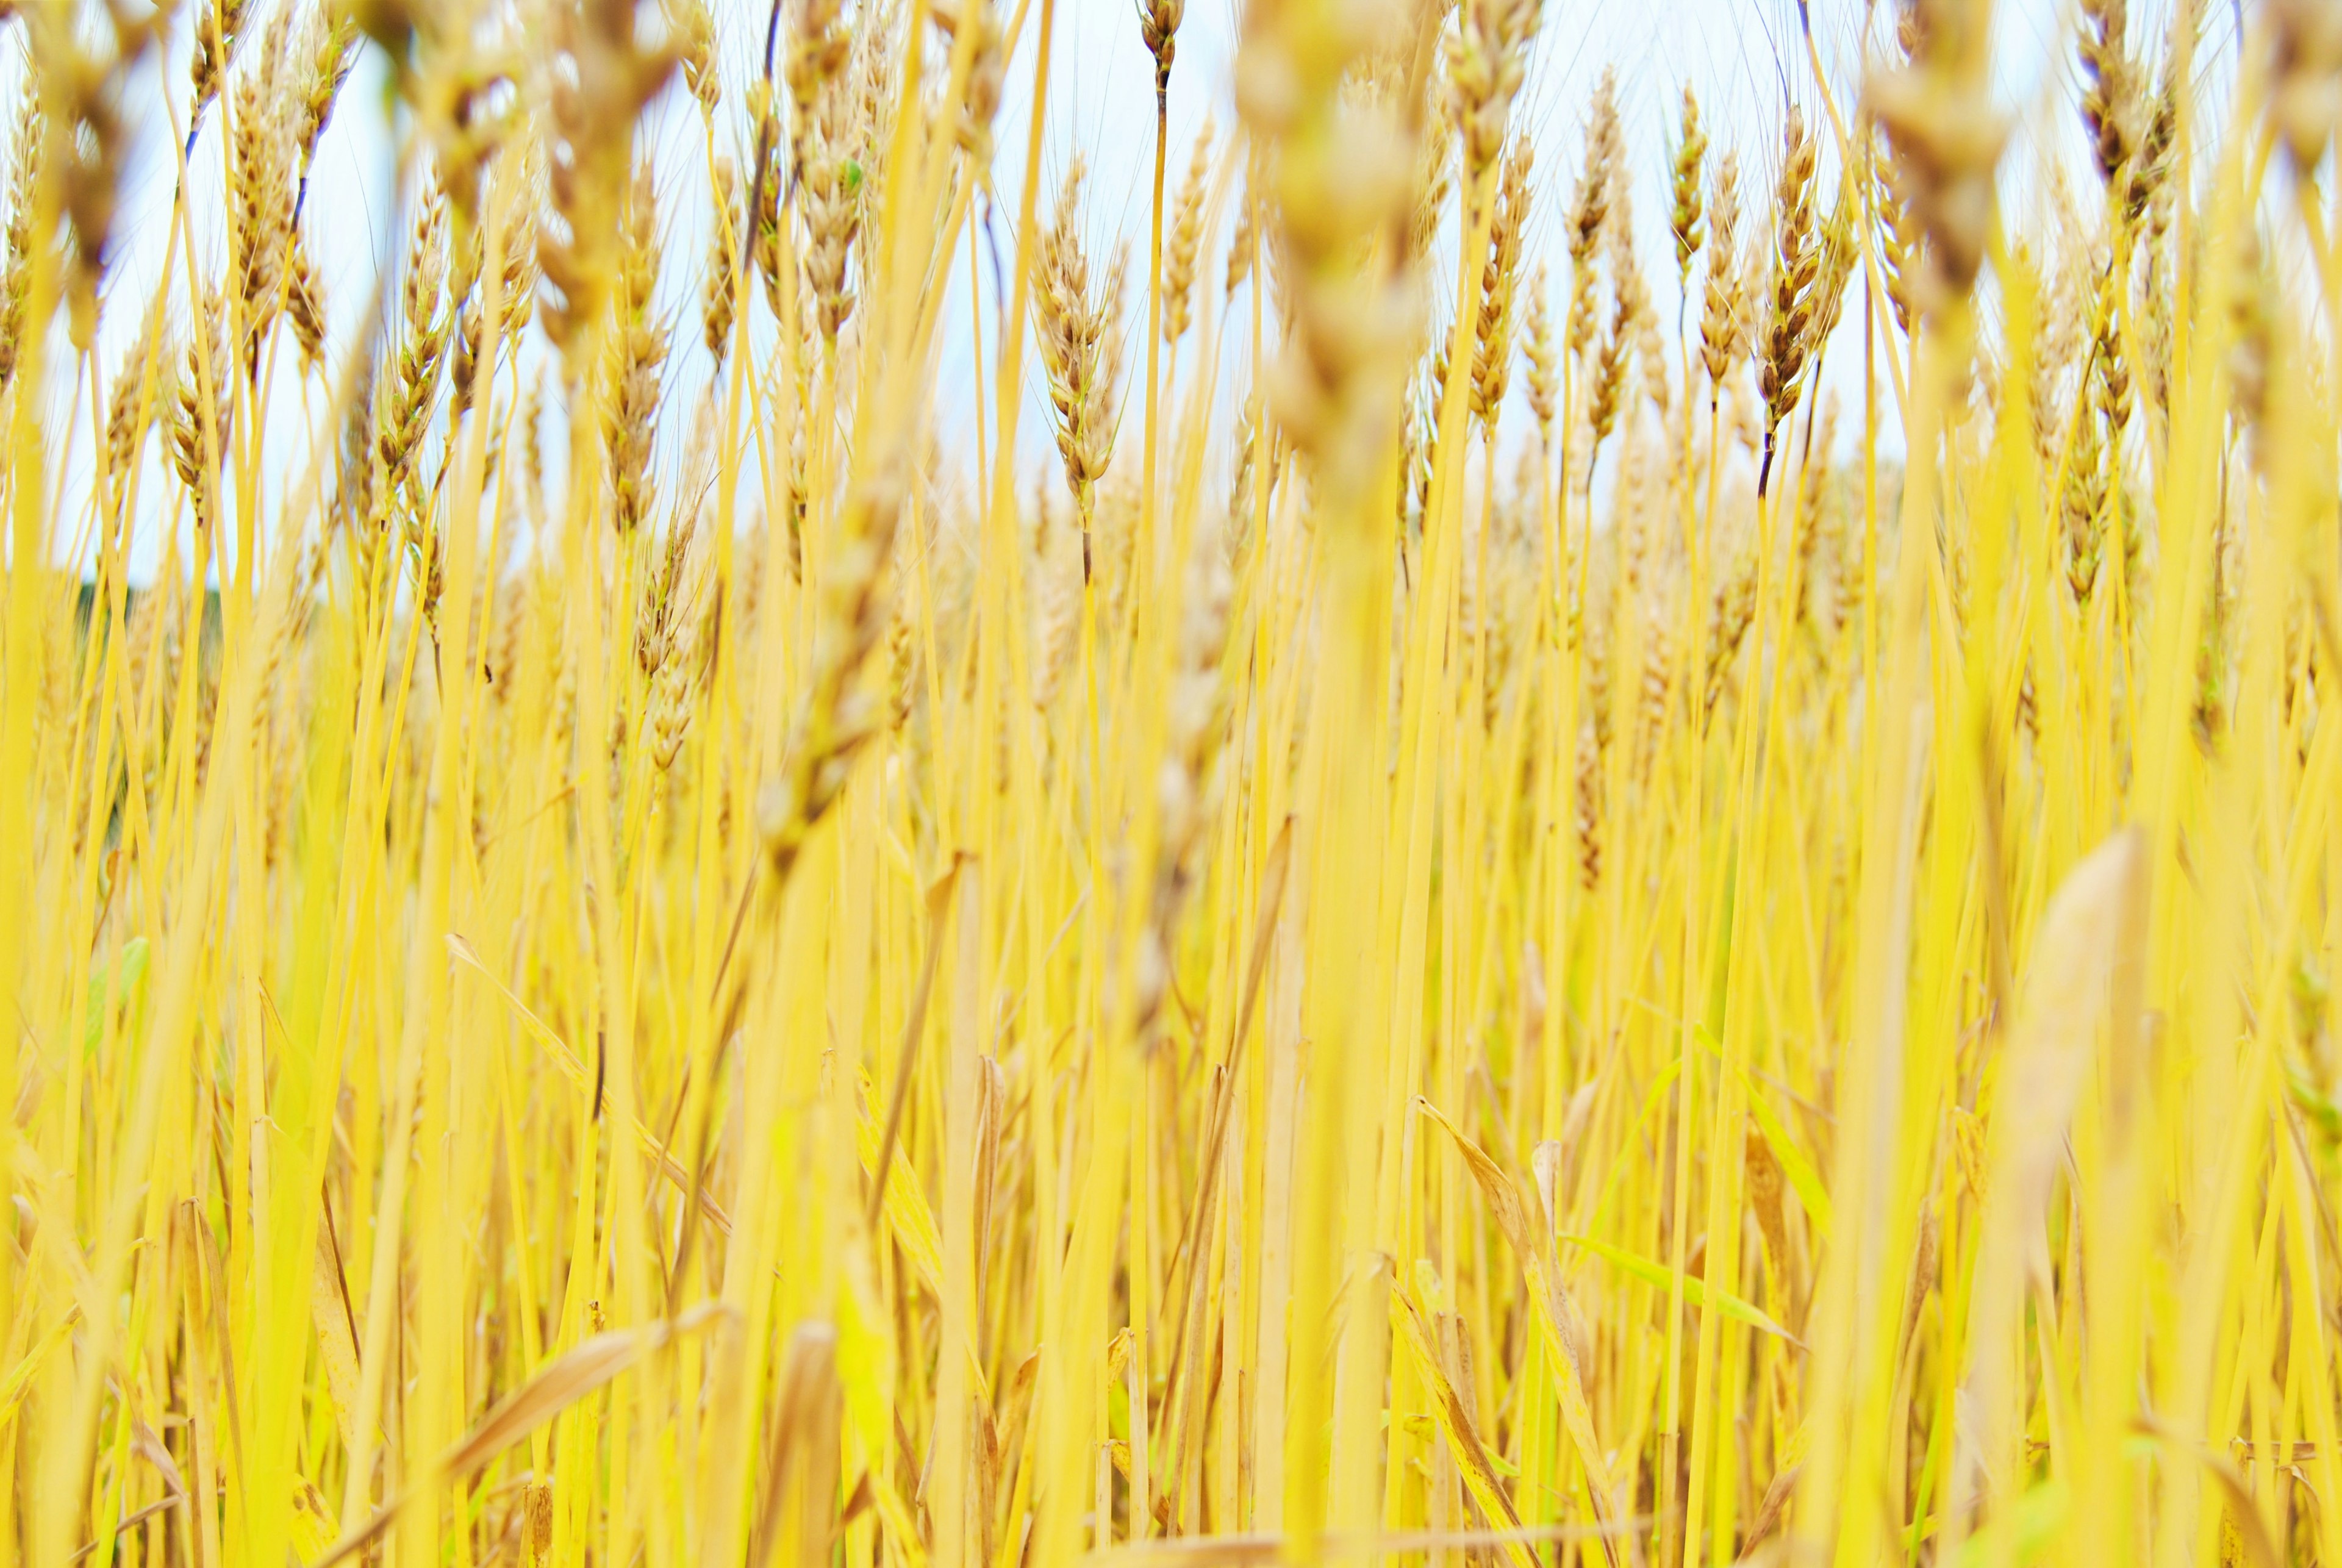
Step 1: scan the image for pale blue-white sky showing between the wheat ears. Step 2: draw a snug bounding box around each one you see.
[5,0,2241,580]
